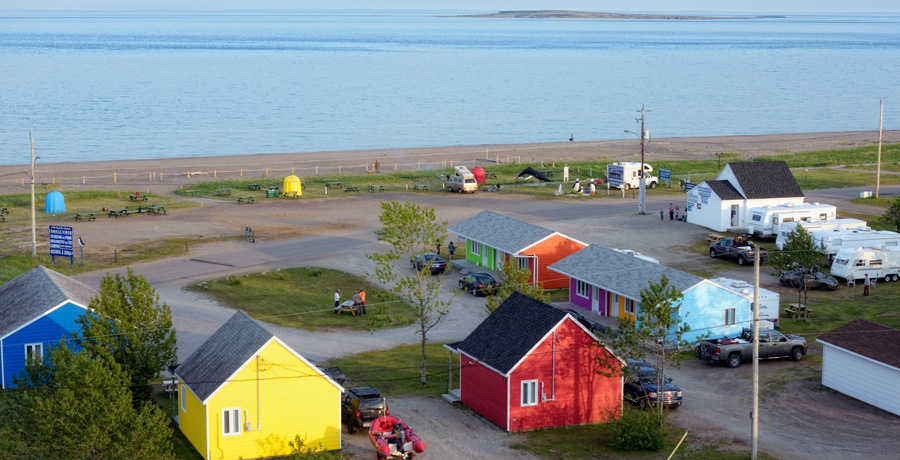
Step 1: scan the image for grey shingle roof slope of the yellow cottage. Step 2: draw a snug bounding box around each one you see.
[175,311,274,402]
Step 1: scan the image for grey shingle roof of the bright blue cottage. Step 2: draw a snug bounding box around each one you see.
[0,266,100,337]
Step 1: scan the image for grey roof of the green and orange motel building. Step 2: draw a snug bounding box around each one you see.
[449,211,555,254]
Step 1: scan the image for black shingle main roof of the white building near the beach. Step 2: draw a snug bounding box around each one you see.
[727,161,803,200]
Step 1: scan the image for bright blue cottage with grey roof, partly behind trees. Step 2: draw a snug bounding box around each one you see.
[0,266,100,389]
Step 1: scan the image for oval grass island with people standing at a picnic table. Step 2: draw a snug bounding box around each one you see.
[188,268,413,333]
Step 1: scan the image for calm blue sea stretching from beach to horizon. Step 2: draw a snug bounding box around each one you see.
[0,12,900,164]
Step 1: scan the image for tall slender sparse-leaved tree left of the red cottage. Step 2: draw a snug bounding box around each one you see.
[368,201,450,385]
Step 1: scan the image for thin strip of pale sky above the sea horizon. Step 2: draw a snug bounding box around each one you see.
[0,0,900,13]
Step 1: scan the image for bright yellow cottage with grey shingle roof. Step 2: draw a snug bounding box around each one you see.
[175,311,344,460]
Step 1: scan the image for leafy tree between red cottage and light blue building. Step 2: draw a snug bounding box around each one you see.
[598,275,697,429]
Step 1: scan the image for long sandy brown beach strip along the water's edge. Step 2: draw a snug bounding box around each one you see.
[0,130,900,191]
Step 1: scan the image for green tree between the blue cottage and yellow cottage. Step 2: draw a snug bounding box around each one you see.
[72,268,178,401]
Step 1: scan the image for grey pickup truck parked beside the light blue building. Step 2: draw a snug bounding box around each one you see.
[697,328,806,367]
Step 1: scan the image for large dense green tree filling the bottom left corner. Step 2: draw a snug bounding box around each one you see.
[0,342,174,460]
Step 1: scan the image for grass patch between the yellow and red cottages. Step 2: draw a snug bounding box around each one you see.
[320,343,459,403]
